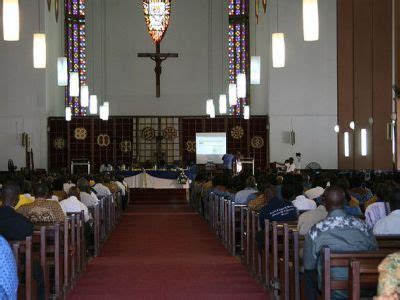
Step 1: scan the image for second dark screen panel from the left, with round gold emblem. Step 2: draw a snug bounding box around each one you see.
[69,118,92,169]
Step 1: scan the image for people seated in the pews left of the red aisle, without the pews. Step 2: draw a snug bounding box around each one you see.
[0,176,127,299]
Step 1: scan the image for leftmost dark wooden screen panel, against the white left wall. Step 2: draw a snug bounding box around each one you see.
[47,118,68,172]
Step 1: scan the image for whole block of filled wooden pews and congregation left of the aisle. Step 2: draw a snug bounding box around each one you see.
[0,173,128,299]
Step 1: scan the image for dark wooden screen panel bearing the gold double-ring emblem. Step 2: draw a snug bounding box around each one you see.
[93,119,116,173]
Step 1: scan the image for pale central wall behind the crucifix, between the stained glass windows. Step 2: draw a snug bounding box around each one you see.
[87,0,233,115]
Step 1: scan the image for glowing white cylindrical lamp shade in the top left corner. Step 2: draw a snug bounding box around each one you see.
[3,0,19,41]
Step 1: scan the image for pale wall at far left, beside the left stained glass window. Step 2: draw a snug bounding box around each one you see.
[0,0,63,170]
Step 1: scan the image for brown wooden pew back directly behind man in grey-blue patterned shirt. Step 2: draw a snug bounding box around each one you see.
[322,248,394,300]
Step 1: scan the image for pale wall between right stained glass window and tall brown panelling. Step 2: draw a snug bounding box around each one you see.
[251,0,338,168]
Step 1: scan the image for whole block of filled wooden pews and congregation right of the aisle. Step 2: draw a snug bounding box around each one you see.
[191,172,400,299]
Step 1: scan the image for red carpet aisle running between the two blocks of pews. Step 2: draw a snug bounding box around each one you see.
[69,205,267,300]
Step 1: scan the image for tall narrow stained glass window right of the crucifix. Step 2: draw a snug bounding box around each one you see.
[228,0,250,116]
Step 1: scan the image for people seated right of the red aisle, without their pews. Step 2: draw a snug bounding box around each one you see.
[192,171,400,299]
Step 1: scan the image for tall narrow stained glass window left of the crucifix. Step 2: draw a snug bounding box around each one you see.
[65,0,87,116]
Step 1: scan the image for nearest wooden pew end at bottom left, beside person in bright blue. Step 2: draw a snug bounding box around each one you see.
[9,236,35,300]
